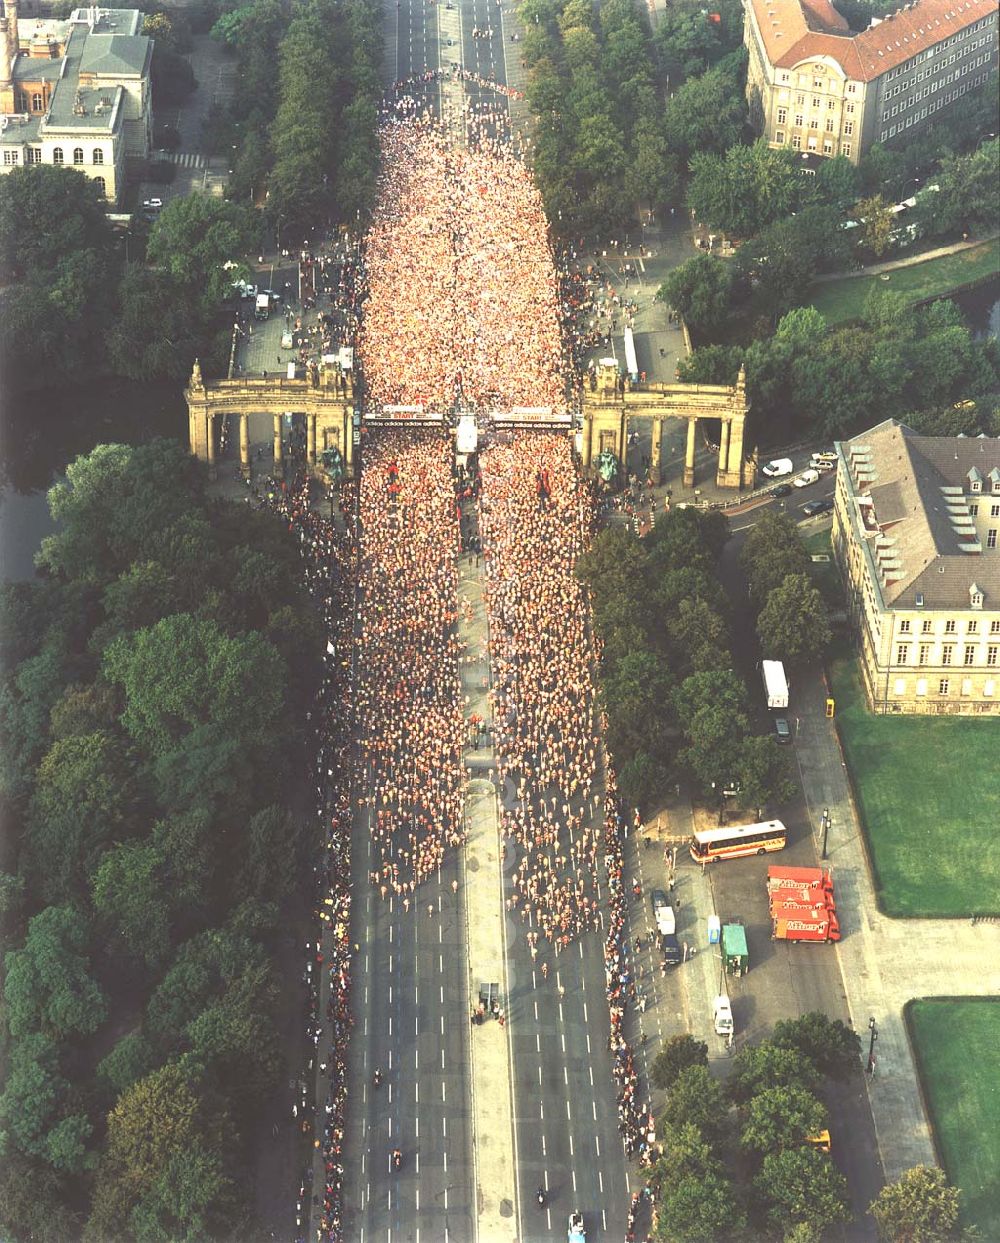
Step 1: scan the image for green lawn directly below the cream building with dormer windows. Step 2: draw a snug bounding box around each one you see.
[831,654,1000,916]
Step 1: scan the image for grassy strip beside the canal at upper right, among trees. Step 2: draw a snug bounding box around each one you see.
[806,239,1000,324]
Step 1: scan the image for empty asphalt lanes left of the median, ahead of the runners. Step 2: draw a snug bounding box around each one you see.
[344,809,475,1243]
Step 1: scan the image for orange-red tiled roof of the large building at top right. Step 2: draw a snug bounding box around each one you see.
[750,0,996,82]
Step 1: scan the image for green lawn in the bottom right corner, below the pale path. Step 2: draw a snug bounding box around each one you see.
[907,997,1000,1241]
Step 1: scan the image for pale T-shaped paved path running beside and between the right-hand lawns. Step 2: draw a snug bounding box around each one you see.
[795,674,1000,1181]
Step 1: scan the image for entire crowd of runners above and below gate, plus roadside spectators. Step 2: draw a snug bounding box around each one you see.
[259,82,652,1243]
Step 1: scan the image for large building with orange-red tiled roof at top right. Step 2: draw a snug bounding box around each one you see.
[743,0,998,164]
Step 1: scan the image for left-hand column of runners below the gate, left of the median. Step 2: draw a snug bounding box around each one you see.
[355,429,463,894]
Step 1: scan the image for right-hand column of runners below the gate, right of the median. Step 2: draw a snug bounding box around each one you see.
[481,433,600,939]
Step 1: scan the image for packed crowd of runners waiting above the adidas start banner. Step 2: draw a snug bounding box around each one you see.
[360,119,566,411]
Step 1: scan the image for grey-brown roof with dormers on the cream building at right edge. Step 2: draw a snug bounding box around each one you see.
[841,419,1000,609]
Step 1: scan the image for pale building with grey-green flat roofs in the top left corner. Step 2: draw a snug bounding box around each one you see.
[0,0,153,203]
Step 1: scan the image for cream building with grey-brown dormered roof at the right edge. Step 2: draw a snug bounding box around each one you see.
[834,419,1000,715]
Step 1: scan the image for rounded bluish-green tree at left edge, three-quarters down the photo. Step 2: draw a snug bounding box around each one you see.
[4,906,107,1039]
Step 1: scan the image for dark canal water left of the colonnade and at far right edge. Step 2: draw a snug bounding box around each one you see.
[0,276,1000,579]
